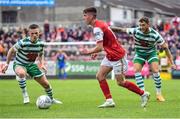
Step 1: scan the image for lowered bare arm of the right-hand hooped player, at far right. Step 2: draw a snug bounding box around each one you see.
[161,42,176,69]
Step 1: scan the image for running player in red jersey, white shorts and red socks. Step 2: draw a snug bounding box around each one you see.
[81,7,150,108]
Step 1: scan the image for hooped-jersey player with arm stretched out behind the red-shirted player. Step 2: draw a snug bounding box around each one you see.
[111,17,176,102]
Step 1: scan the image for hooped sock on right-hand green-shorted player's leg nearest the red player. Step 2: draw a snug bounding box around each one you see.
[135,72,145,90]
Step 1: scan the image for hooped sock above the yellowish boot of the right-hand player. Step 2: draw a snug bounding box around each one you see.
[153,73,161,94]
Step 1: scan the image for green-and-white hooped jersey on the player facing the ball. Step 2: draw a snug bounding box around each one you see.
[13,37,44,65]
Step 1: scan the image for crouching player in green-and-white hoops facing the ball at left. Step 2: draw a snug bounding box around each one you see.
[2,24,62,104]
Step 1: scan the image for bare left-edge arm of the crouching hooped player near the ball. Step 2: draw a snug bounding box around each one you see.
[2,46,16,73]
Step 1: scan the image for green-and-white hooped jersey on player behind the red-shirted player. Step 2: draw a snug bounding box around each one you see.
[126,27,165,55]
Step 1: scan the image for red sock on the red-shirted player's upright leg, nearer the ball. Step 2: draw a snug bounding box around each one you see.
[99,79,112,99]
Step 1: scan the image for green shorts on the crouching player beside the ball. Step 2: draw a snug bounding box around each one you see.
[13,63,44,78]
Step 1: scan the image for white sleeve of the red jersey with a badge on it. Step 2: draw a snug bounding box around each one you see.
[93,27,104,43]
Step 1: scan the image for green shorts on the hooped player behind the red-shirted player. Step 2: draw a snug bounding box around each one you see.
[133,53,159,65]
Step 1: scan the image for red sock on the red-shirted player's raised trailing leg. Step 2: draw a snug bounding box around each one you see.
[122,81,144,95]
